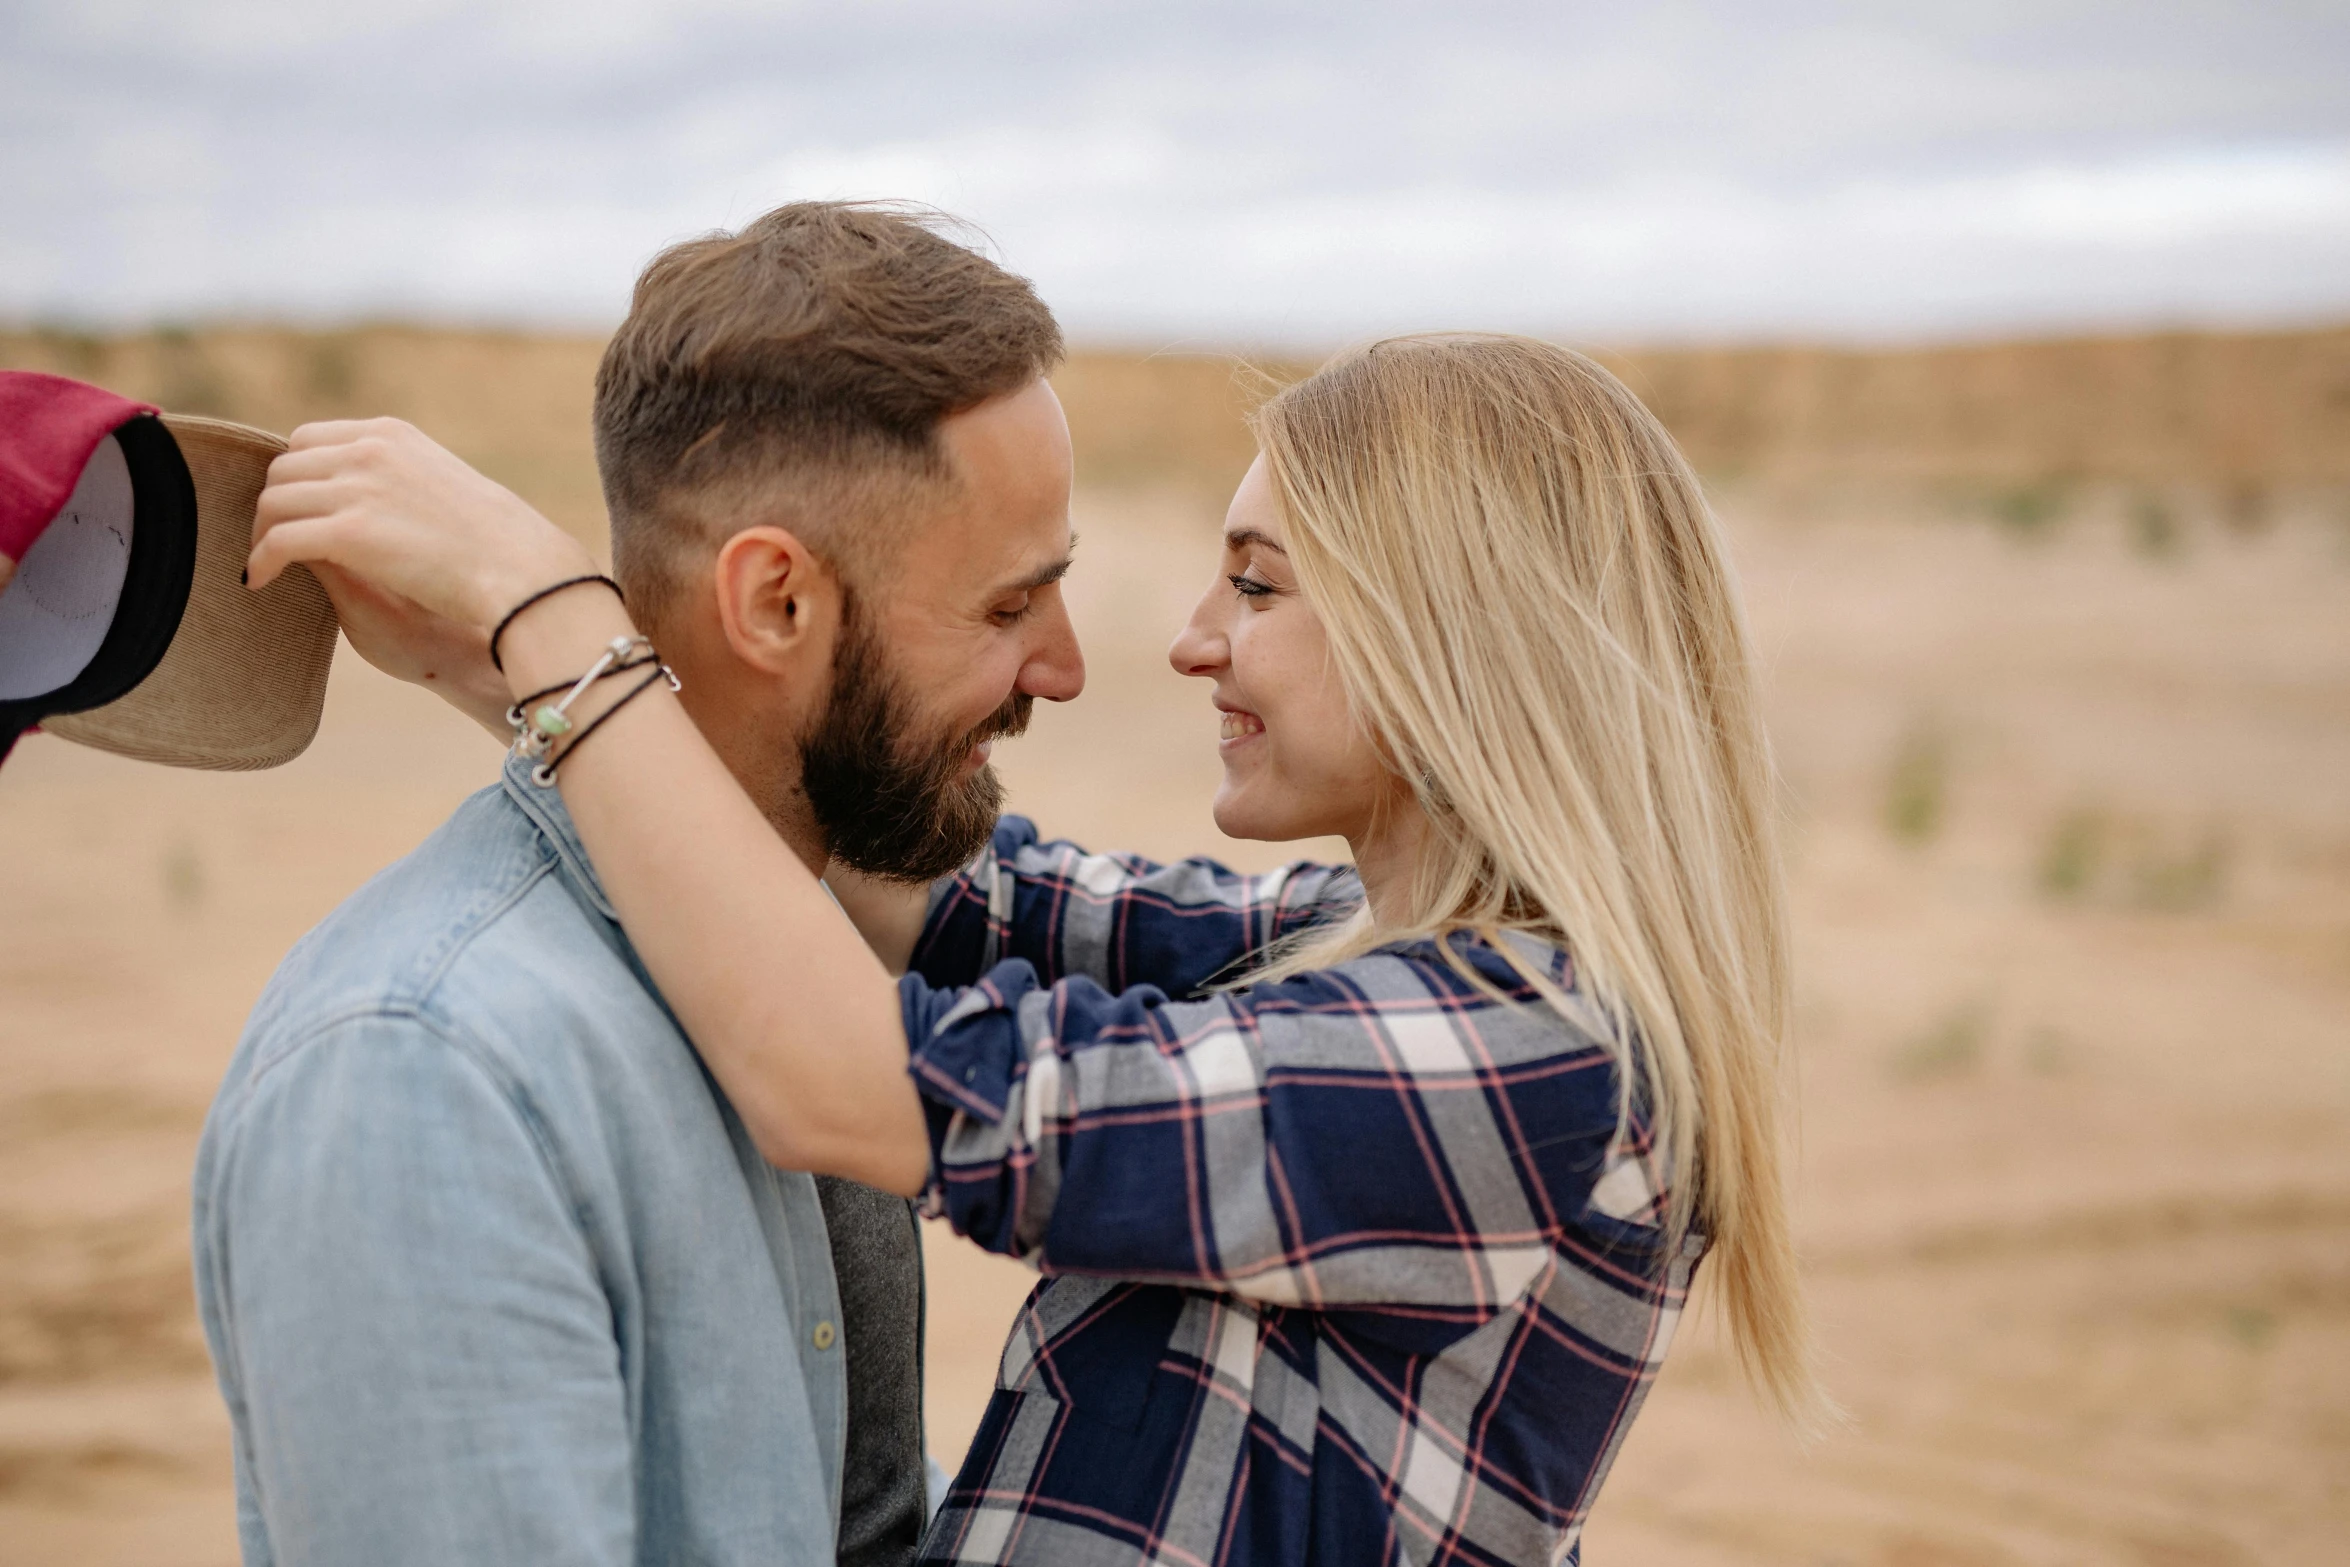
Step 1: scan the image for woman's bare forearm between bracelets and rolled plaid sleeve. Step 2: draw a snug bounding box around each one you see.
[501,592,931,1196]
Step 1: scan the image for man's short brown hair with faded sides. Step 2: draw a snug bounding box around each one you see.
[595,202,1062,620]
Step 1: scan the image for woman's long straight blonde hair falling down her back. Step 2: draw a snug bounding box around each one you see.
[1253,334,1826,1424]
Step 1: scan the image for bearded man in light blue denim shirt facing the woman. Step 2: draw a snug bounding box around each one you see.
[195,202,1083,1565]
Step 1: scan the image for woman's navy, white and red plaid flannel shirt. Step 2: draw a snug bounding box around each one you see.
[902,818,1704,1567]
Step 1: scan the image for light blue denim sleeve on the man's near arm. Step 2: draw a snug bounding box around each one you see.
[195,1015,637,1567]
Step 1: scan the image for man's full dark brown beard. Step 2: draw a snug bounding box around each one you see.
[799,594,1036,883]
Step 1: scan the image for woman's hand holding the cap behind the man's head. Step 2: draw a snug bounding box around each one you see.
[244,418,597,639]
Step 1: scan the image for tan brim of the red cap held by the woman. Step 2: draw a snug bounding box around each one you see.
[40,413,336,773]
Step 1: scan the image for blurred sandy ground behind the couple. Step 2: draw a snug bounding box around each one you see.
[0,328,2350,1567]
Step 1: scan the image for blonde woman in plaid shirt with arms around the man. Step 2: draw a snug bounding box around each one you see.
[254,336,1819,1562]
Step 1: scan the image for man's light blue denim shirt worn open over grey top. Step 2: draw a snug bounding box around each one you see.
[195,751,846,1567]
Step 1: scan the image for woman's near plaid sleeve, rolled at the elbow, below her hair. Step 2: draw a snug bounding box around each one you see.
[900,956,1622,1320]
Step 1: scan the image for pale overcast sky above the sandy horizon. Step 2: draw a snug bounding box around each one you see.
[0,0,2350,343]
